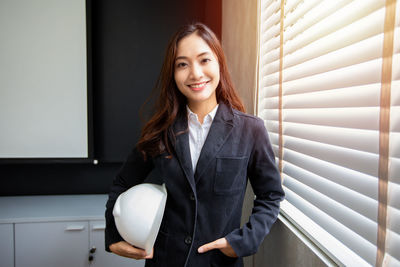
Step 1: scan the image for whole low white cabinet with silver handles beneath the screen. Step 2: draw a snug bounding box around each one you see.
[0,195,144,267]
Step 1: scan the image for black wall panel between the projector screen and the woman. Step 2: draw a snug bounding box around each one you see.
[93,0,204,162]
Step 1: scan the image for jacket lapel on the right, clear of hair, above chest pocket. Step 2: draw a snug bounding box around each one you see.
[194,103,233,183]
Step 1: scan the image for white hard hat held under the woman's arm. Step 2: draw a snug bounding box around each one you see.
[113,183,167,254]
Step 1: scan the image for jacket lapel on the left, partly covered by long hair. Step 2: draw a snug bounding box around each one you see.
[169,112,196,192]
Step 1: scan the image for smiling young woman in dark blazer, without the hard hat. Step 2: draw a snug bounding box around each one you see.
[105,23,284,267]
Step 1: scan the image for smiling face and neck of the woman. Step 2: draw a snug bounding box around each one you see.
[174,33,219,108]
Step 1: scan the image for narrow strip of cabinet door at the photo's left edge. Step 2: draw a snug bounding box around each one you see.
[0,223,14,267]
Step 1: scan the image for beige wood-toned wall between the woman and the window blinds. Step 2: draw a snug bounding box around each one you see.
[222,0,325,267]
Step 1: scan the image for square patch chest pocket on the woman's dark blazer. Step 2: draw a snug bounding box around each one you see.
[214,157,248,195]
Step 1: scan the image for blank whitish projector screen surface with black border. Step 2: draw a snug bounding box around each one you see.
[0,0,88,159]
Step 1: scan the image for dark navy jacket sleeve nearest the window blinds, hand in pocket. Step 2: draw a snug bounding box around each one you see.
[226,119,285,257]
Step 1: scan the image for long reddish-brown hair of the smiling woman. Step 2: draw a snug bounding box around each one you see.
[137,23,245,157]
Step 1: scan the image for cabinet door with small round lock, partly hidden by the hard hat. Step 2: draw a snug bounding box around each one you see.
[90,220,144,267]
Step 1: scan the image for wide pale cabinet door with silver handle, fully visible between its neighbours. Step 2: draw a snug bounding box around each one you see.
[15,221,89,267]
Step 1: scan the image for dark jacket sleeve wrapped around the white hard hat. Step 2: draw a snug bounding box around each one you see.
[105,148,153,252]
